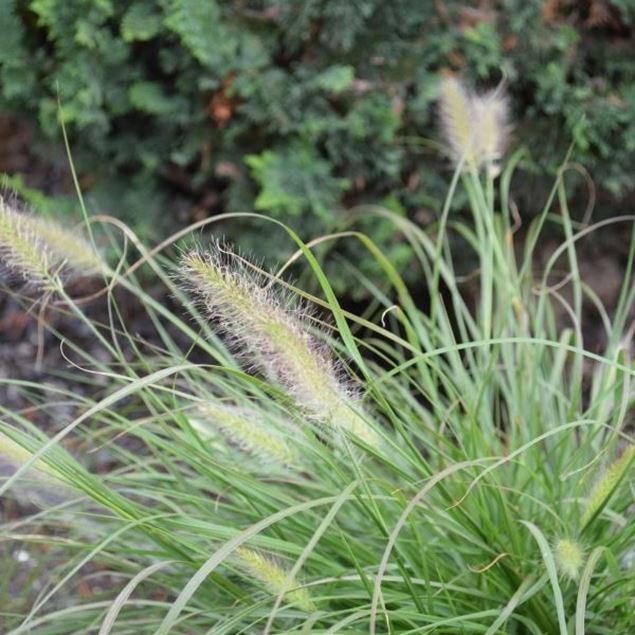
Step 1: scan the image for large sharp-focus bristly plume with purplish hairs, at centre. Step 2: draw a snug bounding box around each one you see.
[181,244,379,446]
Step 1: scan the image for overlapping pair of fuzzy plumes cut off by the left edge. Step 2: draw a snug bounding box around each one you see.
[0,198,102,288]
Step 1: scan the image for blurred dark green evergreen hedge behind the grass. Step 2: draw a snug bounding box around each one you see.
[0,0,635,296]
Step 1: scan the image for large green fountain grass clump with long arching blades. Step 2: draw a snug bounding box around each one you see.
[0,133,635,635]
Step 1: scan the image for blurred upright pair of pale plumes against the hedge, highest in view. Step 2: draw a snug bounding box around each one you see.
[439,76,509,176]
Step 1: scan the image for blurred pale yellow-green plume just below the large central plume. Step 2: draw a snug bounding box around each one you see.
[192,401,297,465]
